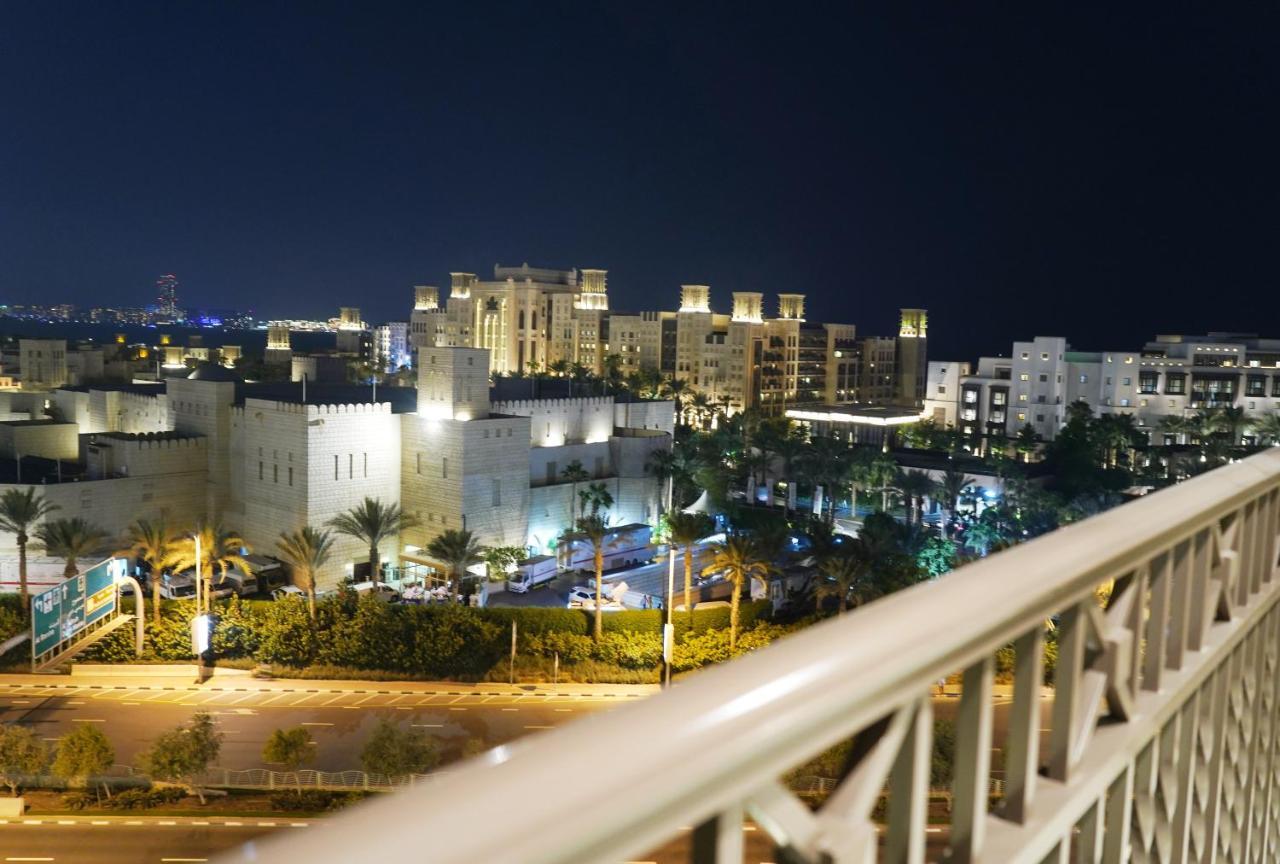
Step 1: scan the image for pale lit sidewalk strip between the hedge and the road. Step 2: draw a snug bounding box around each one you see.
[0,666,662,699]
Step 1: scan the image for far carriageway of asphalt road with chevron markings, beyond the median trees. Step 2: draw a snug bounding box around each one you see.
[0,682,635,771]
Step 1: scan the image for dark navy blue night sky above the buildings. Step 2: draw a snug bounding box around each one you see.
[0,0,1280,358]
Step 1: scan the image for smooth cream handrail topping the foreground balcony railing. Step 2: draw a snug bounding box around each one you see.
[241,449,1280,864]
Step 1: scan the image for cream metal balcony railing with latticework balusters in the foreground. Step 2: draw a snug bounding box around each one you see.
[247,449,1280,864]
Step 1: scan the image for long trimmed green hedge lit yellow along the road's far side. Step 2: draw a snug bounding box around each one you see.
[83,591,788,681]
